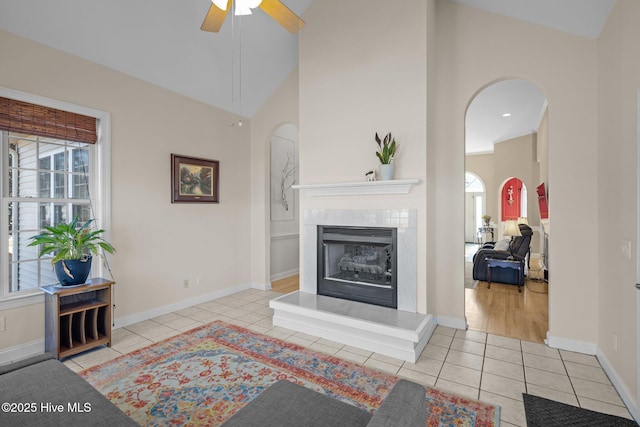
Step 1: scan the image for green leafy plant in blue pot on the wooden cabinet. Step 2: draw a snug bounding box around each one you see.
[29,217,115,286]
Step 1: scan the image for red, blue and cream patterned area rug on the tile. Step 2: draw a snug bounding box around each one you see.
[80,321,500,427]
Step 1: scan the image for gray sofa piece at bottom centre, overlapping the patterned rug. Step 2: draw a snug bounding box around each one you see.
[223,380,427,427]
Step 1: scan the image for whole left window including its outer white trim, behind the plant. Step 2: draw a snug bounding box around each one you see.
[0,88,110,300]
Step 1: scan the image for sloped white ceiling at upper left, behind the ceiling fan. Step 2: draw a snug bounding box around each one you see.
[0,0,312,117]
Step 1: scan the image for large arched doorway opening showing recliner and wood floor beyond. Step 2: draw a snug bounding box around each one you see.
[465,79,548,342]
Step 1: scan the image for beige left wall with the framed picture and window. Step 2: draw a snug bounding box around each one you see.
[0,31,251,348]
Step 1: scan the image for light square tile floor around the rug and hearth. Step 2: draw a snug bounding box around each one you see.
[64,290,631,426]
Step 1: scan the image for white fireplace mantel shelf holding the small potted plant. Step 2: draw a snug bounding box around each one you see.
[293,179,422,197]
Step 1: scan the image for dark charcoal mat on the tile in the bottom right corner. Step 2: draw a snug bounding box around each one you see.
[522,393,637,427]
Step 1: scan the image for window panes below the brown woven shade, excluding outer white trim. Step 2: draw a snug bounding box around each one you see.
[0,131,93,292]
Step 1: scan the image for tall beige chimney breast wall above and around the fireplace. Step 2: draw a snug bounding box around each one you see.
[299,0,427,313]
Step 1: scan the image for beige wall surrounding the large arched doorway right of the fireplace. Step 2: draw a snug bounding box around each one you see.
[430,0,598,340]
